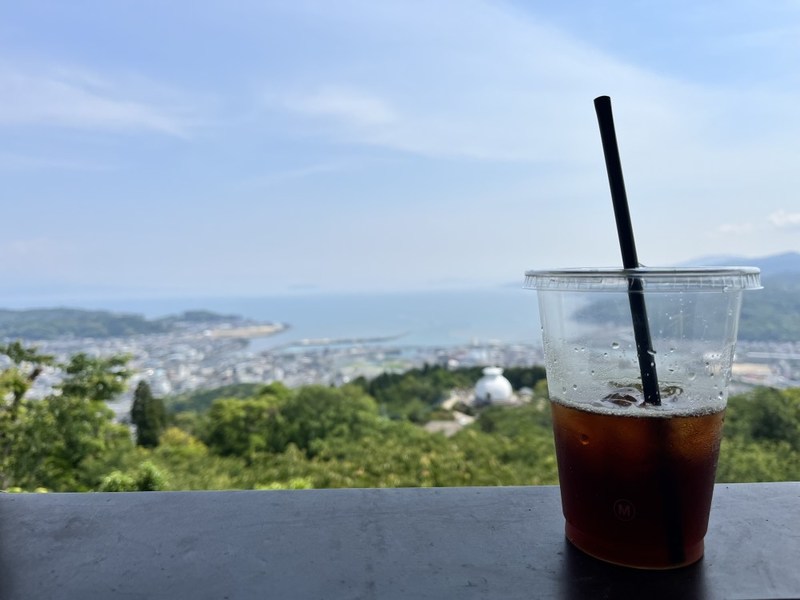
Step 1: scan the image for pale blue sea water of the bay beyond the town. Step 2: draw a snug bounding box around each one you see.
[76,285,541,350]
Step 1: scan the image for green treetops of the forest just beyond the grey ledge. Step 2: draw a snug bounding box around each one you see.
[0,343,800,491]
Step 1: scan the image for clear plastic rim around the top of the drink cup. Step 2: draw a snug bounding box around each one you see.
[523,267,761,293]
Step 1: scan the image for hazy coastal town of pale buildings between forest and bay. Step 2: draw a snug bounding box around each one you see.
[7,322,800,418]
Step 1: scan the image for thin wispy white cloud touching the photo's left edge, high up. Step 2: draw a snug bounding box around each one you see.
[0,65,188,136]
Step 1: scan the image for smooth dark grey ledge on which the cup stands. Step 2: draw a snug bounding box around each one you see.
[0,483,800,600]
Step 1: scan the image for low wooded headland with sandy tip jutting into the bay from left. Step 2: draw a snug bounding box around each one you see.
[0,308,285,340]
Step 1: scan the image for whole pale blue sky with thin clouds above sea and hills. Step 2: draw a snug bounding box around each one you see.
[0,0,800,306]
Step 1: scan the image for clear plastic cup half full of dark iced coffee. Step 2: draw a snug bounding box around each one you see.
[525,267,761,569]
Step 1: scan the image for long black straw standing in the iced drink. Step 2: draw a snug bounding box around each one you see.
[594,96,661,406]
